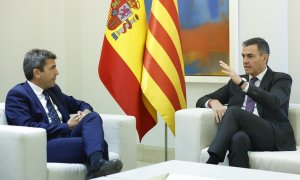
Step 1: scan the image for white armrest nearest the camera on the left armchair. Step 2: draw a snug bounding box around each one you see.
[0,125,47,180]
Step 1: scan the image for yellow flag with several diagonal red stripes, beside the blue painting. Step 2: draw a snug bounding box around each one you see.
[141,0,186,134]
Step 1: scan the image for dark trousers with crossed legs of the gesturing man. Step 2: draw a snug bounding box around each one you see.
[208,107,276,168]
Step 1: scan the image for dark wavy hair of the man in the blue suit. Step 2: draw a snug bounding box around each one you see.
[23,49,56,80]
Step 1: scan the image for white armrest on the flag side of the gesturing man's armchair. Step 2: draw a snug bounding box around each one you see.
[175,108,218,162]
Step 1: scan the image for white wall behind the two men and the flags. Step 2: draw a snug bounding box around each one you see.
[0,0,300,147]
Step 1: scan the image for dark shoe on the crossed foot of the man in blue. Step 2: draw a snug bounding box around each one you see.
[93,159,123,177]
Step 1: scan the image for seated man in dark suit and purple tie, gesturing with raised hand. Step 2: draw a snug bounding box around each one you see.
[196,38,296,168]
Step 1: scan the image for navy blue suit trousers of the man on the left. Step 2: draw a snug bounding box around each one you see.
[47,112,108,163]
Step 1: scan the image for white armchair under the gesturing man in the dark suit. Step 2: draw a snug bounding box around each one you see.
[175,104,300,174]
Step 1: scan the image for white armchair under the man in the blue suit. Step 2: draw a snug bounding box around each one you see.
[0,103,137,180]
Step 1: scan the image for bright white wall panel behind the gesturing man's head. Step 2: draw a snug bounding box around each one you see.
[239,0,288,72]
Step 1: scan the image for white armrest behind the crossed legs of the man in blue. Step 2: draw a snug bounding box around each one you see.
[101,114,137,170]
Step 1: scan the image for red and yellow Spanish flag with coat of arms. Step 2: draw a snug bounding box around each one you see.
[98,0,157,140]
